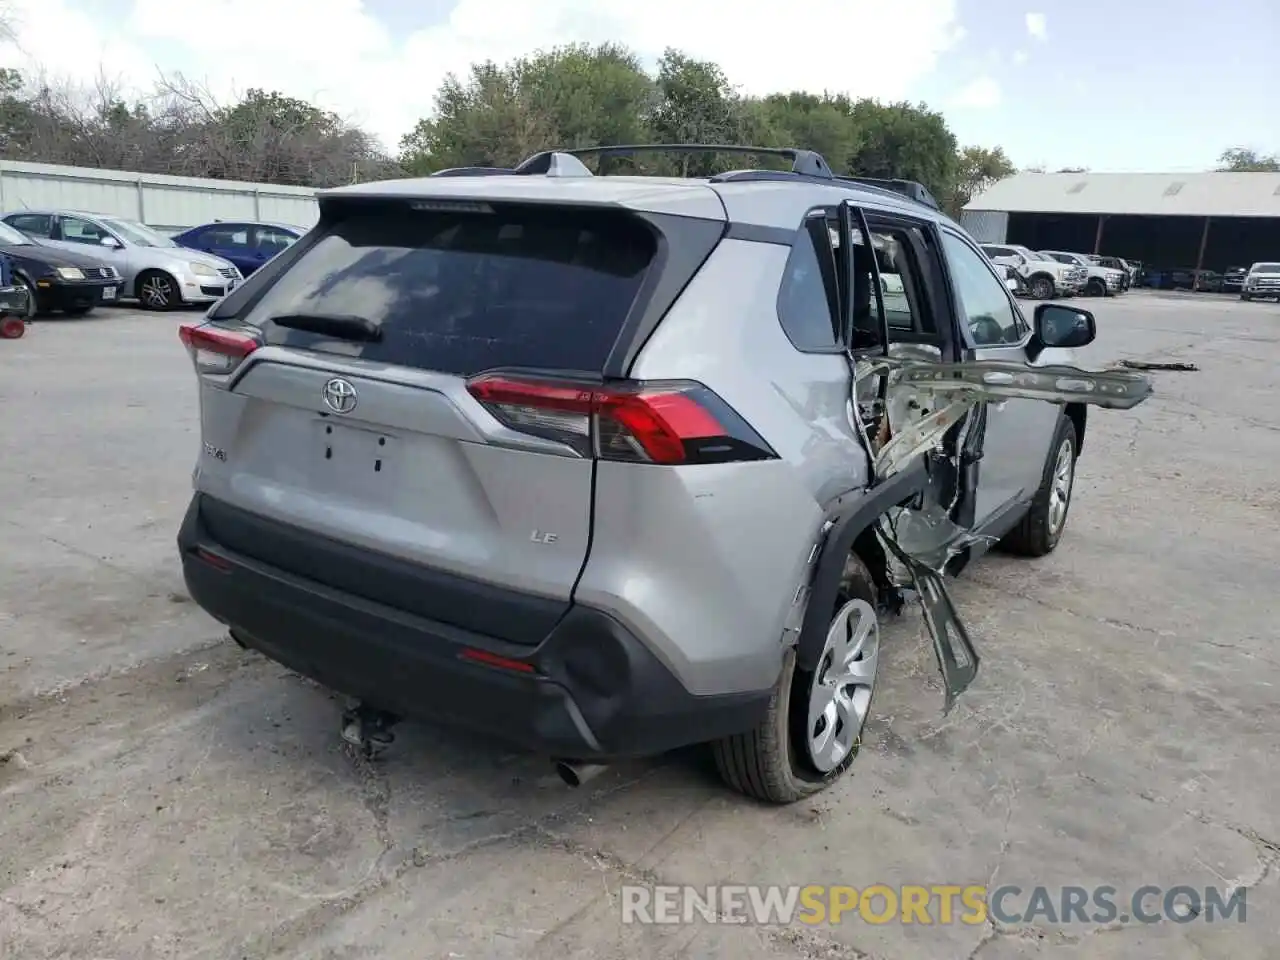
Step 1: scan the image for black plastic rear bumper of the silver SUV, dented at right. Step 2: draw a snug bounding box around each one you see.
[178,494,771,762]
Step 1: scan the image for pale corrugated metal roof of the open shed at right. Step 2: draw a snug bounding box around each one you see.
[964,173,1280,218]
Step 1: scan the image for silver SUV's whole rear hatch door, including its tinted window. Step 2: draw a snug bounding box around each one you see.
[197,200,675,644]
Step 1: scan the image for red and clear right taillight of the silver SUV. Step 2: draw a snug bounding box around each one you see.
[467,374,777,463]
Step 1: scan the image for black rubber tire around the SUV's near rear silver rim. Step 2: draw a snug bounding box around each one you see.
[710,553,876,804]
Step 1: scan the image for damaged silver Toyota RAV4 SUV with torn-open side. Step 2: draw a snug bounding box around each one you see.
[178,146,1151,803]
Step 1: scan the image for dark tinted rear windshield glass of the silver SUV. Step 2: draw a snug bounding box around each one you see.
[244,205,655,376]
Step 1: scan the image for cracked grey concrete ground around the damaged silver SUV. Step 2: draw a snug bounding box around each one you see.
[0,292,1280,960]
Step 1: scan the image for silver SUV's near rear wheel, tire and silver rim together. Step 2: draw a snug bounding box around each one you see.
[712,554,879,804]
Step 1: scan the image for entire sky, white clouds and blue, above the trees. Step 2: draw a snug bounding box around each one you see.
[0,0,1280,172]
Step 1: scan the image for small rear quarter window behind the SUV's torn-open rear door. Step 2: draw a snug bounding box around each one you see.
[778,216,840,351]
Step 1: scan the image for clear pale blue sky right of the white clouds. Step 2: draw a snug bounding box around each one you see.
[918,0,1280,172]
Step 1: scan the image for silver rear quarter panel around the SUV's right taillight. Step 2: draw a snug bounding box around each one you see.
[575,239,867,694]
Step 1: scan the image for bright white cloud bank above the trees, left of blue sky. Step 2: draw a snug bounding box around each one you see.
[0,0,961,148]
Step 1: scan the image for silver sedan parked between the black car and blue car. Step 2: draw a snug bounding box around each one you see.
[0,210,244,310]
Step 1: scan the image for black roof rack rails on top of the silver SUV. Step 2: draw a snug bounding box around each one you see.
[431,143,942,210]
